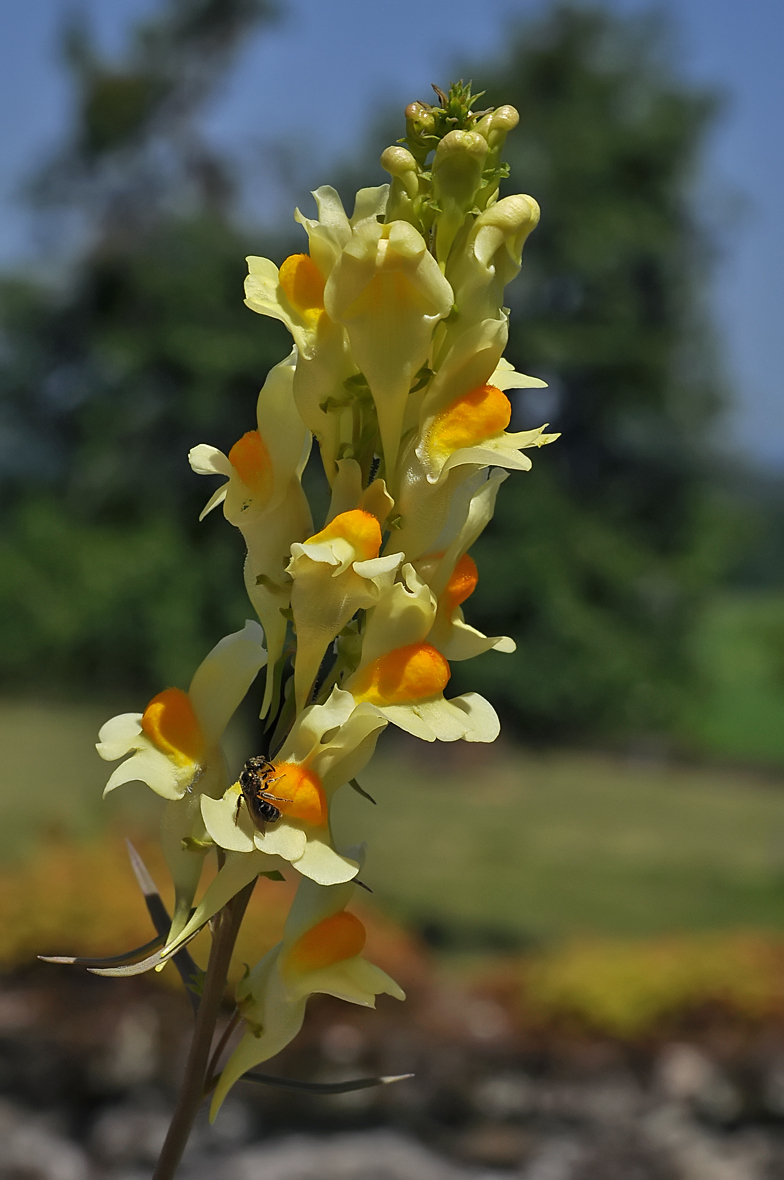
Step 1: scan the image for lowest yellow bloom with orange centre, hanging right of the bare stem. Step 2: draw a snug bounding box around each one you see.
[210,879,405,1120]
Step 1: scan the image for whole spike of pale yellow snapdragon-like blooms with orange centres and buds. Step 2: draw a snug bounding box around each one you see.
[98,85,556,1110]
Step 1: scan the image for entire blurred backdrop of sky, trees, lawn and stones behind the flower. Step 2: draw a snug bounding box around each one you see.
[0,0,784,1180]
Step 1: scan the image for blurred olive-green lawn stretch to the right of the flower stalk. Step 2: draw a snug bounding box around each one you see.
[335,749,784,949]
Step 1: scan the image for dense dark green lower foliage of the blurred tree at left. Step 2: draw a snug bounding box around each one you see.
[0,211,287,688]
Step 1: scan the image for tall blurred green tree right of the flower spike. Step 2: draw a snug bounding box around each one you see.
[441,5,734,740]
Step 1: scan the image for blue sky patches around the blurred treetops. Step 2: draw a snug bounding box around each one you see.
[0,0,784,471]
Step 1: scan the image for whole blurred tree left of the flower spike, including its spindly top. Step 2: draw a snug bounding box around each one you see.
[0,0,288,689]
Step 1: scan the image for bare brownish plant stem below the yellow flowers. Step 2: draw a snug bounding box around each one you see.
[152,880,256,1180]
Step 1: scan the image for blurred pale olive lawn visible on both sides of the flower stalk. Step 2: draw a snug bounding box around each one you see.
[0,703,784,950]
